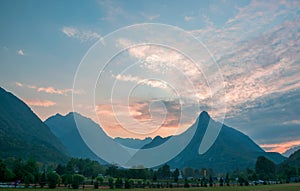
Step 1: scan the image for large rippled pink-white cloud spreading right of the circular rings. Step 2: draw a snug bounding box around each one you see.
[191,1,300,119]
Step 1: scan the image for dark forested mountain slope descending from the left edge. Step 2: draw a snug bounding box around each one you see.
[0,88,68,163]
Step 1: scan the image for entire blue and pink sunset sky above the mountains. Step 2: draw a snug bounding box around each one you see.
[0,0,300,153]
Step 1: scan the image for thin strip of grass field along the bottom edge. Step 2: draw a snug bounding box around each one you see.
[0,183,300,191]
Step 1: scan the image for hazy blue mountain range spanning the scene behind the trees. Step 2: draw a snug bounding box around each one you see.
[0,88,286,172]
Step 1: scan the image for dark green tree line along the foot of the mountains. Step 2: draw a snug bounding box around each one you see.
[0,156,299,188]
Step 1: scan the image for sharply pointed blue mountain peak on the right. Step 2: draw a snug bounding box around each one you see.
[144,112,285,172]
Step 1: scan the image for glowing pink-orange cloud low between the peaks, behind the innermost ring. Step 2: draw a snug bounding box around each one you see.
[96,100,194,138]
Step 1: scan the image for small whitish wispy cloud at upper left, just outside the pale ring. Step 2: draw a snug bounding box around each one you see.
[61,26,101,42]
